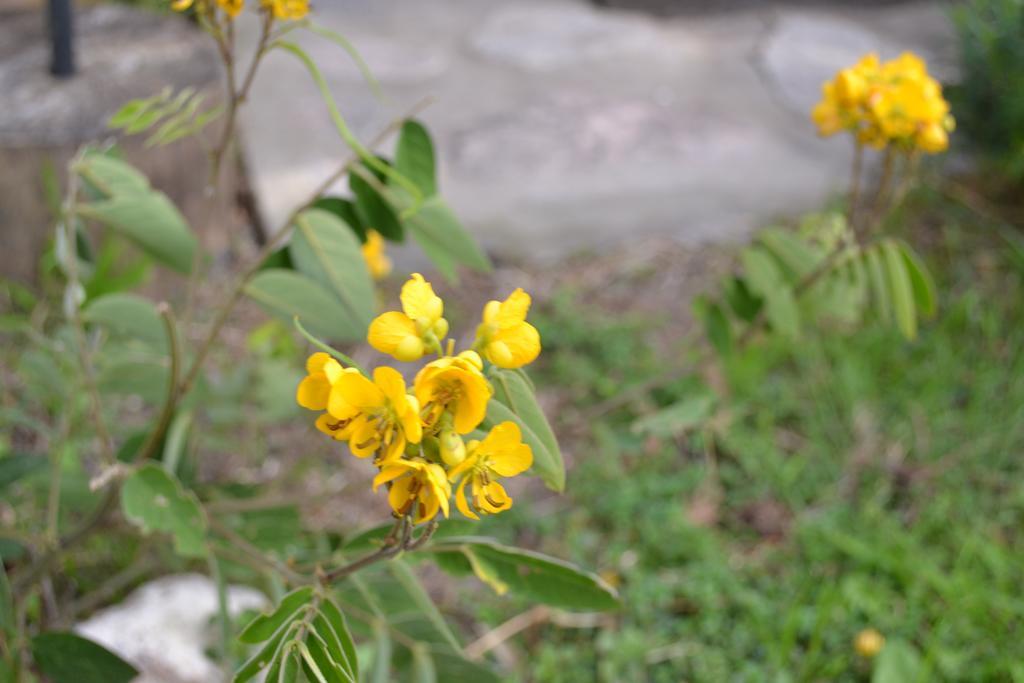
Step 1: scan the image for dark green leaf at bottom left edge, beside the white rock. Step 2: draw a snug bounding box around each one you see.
[32,632,138,683]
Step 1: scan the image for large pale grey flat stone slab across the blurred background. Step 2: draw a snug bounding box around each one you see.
[235,0,955,261]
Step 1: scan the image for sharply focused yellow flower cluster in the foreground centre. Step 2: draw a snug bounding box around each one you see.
[296,273,541,523]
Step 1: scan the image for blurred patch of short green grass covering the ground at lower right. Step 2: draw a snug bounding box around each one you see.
[481,194,1024,683]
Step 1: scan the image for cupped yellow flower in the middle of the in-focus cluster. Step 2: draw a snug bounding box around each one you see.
[414,351,493,434]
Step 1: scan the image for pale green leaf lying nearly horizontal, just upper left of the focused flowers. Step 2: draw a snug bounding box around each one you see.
[246,268,366,341]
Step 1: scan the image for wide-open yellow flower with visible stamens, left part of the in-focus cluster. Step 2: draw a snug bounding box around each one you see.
[331,368,423,462]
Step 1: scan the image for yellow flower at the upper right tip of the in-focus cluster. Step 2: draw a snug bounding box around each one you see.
[473,289,541,369]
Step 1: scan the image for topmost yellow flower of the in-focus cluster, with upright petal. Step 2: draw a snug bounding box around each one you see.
[368,272,449,362]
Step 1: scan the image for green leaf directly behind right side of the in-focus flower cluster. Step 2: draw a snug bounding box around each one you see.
[483,368,565,492]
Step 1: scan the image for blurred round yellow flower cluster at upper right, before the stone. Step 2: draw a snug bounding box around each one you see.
[811,52,954,154]
